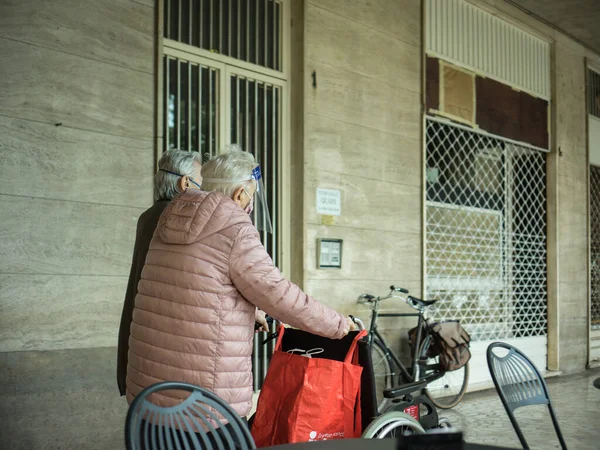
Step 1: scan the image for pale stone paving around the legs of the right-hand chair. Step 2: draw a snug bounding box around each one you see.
[439,370,600,450]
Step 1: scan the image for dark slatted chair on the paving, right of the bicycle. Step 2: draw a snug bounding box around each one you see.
[487,342,567,450]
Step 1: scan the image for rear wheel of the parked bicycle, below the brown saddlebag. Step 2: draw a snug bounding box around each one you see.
[419,339,469,409]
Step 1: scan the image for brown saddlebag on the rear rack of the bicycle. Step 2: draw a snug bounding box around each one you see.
[430,320,471,372]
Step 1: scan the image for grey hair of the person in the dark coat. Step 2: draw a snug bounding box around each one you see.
[154,150,202,200]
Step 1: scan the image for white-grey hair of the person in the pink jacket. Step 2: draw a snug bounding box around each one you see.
[202,144,257,197]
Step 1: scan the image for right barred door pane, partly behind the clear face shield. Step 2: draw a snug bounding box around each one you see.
[229,75,281,264]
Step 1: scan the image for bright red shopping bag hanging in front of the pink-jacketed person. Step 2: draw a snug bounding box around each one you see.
[252,326,367,448]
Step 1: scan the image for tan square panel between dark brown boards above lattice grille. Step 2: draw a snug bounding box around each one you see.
[441,64,475,123]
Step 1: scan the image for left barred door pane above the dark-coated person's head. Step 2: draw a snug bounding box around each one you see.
[163,56,220,157]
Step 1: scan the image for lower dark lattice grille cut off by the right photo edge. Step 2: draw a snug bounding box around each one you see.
[590,166,600,329]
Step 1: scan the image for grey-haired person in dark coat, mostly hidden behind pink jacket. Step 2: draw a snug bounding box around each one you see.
[117,150,202,395]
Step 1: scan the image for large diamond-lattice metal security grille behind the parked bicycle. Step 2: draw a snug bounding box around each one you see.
[426,117,547,340]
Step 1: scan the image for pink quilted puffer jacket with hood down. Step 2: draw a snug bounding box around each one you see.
[127,190,348,416]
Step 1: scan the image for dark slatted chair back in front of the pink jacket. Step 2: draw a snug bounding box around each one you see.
[125,382,256,450]
